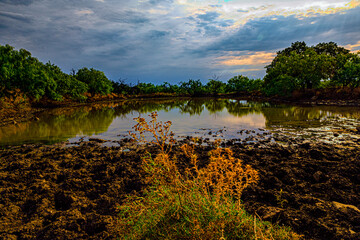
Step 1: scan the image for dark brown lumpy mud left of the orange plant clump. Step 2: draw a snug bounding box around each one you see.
[0,144,153,239]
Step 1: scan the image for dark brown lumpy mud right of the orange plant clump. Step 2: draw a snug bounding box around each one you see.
[233,141,360,239]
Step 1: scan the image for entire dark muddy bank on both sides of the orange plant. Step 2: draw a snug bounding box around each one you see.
[0,136,360,239]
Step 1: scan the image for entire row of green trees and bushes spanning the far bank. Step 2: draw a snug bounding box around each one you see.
[0,42,360,101]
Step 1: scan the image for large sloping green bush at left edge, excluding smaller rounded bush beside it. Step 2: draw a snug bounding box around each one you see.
[0,45,88,100]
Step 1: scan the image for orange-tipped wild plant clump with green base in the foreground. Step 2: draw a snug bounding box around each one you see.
[119,113,300,240]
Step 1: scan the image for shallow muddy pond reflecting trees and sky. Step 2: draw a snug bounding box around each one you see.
[0,98,360,145]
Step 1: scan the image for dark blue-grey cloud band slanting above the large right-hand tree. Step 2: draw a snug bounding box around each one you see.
[201,8,360,55]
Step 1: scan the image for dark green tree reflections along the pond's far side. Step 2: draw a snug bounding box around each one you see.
[0,98,360,144]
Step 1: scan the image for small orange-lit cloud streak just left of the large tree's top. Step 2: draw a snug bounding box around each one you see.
[217,52,276,66]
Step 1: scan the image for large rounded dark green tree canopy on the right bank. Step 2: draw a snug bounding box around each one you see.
[264,42,359,96]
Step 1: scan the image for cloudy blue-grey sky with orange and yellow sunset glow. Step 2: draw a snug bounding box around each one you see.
[0,0,360,84]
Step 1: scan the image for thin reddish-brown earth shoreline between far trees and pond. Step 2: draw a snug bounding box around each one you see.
[0,90,360,127]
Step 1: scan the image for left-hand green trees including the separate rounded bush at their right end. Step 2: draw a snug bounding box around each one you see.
[0,45,113,100]
